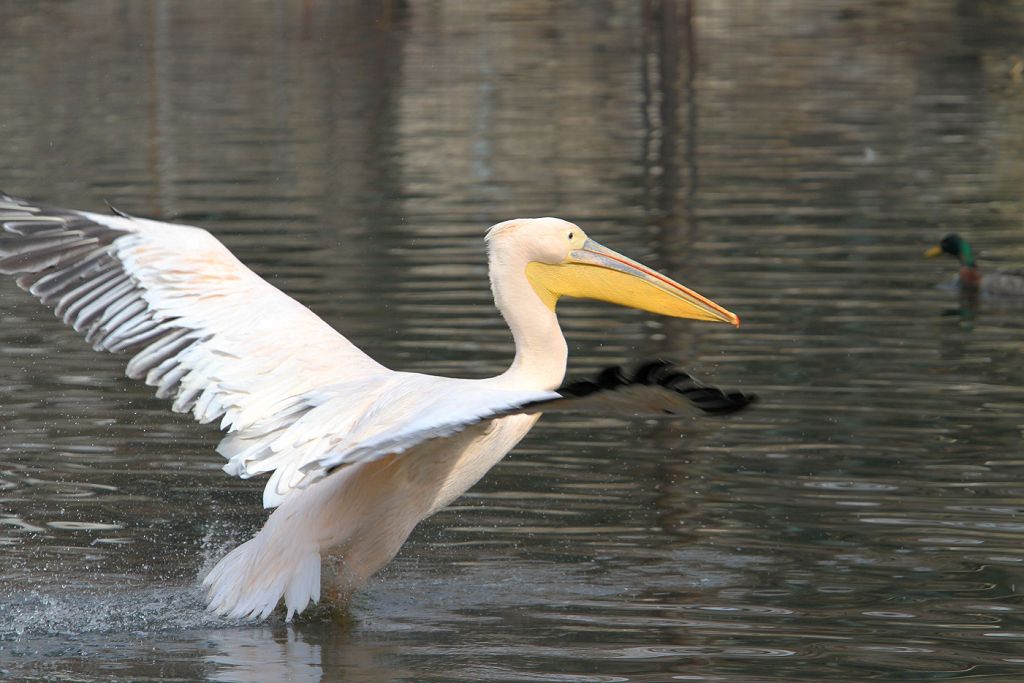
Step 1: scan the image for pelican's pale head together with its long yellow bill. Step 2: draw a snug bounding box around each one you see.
[487,218,739,327]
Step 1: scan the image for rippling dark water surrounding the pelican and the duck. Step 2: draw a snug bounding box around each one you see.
[0,0,1024,682]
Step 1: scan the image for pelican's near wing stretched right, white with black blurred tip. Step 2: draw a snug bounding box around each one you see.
[307,360,757,486]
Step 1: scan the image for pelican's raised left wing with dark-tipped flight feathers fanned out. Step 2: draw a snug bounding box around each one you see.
[0,195,392,485]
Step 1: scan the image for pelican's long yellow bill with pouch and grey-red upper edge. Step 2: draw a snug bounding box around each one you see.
[526,239,739,327]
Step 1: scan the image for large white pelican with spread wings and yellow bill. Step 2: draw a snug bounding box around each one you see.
[0,194,753,621]
